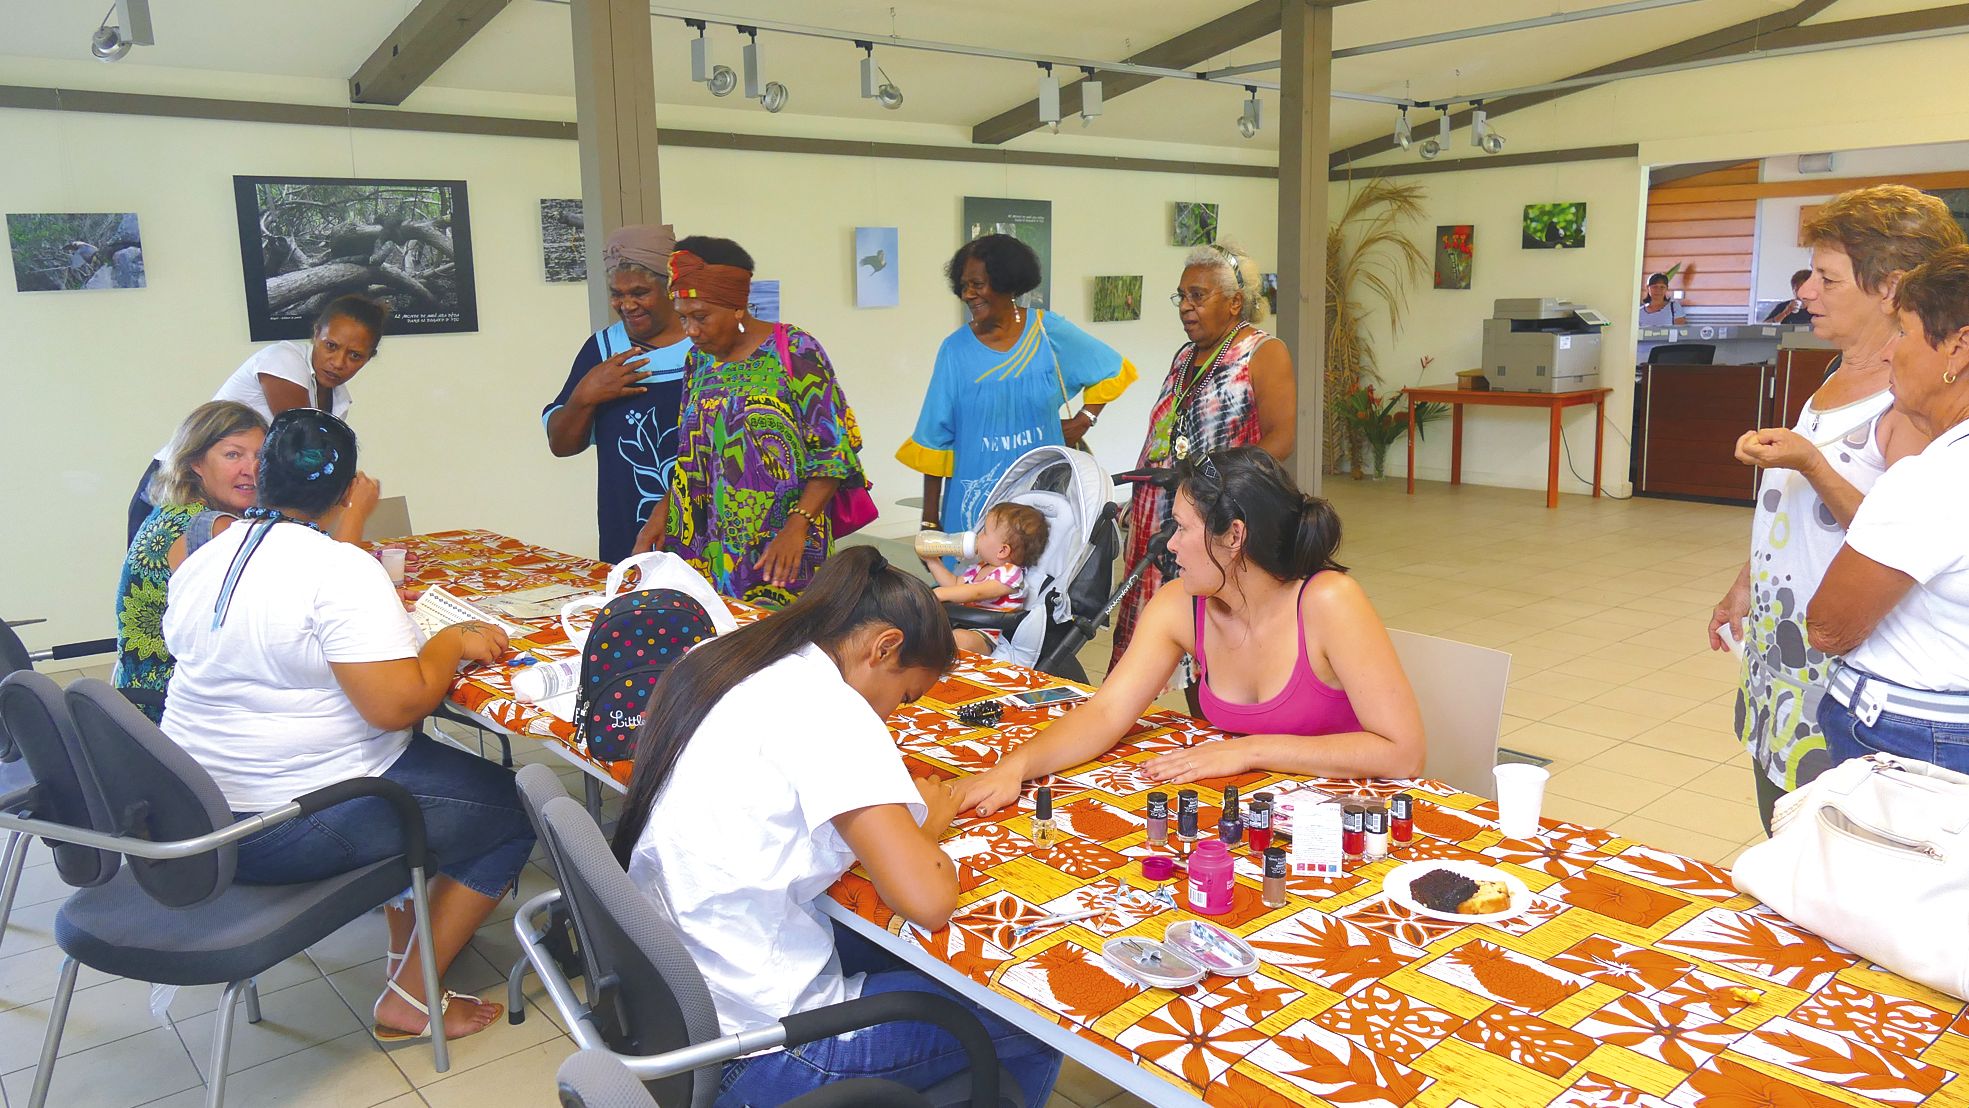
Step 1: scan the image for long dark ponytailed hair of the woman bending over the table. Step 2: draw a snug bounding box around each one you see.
[612,547,957,868]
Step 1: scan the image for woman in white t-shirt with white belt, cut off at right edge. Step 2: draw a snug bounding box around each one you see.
[1811,246,1969,771]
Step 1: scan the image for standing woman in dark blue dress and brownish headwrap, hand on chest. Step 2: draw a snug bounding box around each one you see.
[540,224,691,561]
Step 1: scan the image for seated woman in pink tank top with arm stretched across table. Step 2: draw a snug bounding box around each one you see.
[957,447,1424,813]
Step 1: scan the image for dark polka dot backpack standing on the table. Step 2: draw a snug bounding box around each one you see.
[575,588,719,762]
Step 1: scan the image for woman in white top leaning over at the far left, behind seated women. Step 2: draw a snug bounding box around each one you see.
[124,295,390,541]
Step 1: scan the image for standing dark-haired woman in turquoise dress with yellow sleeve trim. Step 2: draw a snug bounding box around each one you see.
[896,234,1136,531]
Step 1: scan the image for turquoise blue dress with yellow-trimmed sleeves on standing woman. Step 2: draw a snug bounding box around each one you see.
[896,309,1138,531]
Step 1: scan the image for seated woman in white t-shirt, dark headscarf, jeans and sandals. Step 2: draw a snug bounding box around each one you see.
[161,407,534,1041]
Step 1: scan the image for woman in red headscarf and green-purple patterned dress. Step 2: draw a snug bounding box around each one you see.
[666,236,868,606]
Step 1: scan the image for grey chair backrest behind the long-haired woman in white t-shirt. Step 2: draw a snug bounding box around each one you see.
[541,797,723,1108]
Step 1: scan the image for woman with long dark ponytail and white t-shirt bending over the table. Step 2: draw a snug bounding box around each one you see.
[614,547,1059,1108]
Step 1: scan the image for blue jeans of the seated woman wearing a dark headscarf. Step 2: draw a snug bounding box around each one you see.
[232,734,534,897]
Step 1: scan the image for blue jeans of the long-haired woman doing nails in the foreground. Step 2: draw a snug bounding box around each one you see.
[717,923,1059,1108]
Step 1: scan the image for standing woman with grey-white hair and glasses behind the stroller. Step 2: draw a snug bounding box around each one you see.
[1114,244,1300,661]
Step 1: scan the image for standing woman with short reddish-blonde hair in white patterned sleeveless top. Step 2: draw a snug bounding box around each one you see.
[1709,185,1963,831]
